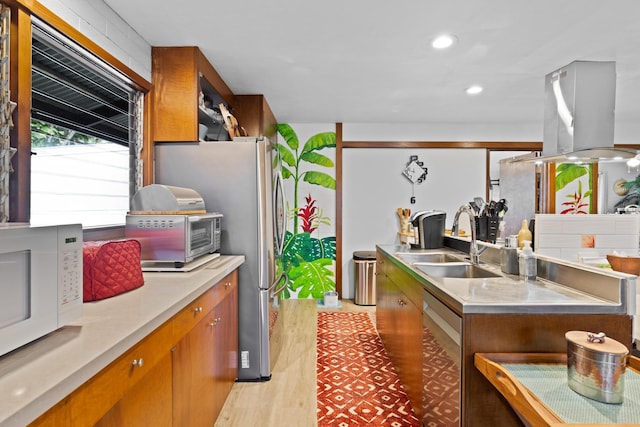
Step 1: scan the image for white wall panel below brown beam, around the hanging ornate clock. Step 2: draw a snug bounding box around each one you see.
[340,148,485,298]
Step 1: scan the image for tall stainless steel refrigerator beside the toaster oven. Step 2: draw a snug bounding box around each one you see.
[155,138,287,381]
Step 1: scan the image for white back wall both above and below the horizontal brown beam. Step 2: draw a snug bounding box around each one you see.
[340,122,542,298]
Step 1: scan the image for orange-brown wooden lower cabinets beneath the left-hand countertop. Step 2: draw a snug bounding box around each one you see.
[30,270,238,427]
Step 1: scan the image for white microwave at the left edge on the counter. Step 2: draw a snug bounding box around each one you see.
[0,223,82,356]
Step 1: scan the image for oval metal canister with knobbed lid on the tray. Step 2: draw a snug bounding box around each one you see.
[565,331,629,403]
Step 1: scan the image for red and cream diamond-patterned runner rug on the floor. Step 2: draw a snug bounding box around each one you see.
[316,311,420,427]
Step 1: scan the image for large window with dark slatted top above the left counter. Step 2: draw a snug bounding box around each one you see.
[30,19,142,228]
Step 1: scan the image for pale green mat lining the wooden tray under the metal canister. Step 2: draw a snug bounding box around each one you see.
[502,363,640,424]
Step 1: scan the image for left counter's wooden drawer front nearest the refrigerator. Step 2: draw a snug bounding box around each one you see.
[172,271,238,341]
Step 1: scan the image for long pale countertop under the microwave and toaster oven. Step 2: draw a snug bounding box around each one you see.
[0,256,245,427]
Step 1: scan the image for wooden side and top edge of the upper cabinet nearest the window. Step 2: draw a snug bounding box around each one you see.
[151,46,233,142]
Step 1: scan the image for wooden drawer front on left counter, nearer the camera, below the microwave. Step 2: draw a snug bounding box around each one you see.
[69,323,174,426]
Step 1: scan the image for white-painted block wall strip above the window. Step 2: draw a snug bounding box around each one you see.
[39,0,151,81]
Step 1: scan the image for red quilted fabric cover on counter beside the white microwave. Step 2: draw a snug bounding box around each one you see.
[82,240,144,301]
